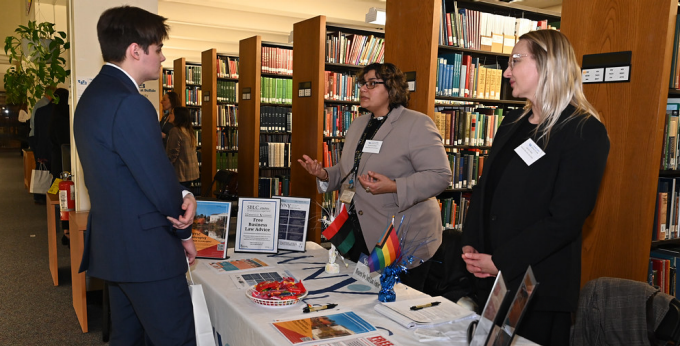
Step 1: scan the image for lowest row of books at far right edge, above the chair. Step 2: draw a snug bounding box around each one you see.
[647,248,680,296]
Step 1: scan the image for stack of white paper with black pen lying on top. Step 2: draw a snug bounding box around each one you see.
[374,297,475,328]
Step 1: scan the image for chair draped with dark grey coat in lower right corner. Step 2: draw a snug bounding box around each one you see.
[571,277,680,346]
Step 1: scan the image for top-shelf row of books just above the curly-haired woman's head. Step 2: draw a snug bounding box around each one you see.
[326,31,385,65]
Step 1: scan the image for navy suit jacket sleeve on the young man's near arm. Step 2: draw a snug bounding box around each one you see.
[113,94,191,239]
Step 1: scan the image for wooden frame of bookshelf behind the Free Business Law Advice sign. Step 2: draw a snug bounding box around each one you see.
[238,36,292,197]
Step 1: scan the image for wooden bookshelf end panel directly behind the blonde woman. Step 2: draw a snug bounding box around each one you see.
[561,0,678,284]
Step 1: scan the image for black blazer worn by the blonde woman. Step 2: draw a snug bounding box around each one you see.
[463,106,609,311]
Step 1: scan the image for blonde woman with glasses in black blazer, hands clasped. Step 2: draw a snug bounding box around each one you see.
[456,30,609,345]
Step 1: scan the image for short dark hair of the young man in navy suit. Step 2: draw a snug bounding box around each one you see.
[97,6,170,62]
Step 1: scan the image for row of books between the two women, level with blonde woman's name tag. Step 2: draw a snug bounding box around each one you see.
[446,148,487,189]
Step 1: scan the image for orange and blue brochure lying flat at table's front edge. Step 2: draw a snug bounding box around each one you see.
[272,311,376,345]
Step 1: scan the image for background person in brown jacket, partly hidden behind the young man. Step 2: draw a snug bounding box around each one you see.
[165,107,200,188]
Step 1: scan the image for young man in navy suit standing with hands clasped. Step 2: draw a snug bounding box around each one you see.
[73,6,196,346]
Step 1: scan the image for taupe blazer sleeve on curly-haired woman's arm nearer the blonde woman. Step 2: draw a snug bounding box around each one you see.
[394,115,451,212]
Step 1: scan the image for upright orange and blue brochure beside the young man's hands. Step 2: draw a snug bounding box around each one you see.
[191,200,231,259]
